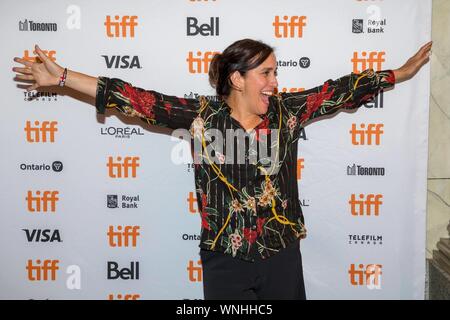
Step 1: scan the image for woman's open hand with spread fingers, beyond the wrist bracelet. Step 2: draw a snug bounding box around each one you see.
[13,45,64,91]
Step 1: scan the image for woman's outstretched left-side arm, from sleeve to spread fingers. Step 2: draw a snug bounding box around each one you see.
[13,46,200,129]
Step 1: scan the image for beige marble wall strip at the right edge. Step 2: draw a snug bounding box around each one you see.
[427,0,450,258]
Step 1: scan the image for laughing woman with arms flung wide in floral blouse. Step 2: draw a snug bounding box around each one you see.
[13,39,431,300]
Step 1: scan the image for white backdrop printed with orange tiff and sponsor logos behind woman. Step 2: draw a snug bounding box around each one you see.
[0,0,431,299]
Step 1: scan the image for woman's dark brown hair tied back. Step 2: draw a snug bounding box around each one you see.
[209,39,273,97]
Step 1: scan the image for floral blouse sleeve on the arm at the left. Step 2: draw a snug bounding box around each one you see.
[95,77,199,129]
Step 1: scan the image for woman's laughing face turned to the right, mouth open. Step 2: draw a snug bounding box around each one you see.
[242,53,278,115]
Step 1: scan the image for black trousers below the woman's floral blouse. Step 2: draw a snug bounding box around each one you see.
[200,240,306,300]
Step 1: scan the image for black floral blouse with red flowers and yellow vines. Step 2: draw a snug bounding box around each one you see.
[96,69,395,261]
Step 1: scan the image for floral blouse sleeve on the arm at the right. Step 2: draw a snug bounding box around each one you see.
[281,69,395,126]
